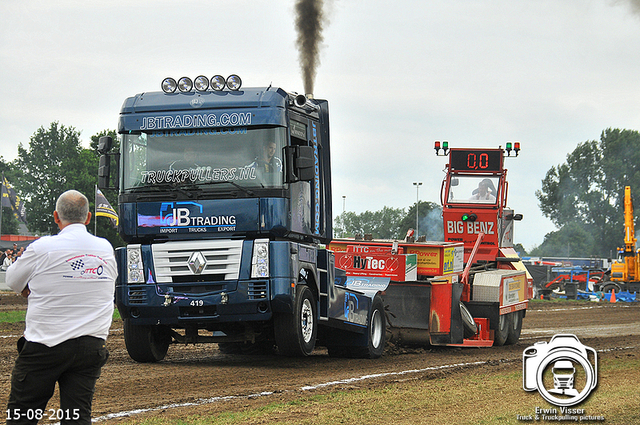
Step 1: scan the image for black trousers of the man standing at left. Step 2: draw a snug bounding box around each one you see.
[6,336,109,425]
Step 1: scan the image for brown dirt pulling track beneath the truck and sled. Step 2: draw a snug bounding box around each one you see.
[0,293,640,423]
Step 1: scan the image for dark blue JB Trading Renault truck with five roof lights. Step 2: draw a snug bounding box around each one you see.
[98,75,388,362]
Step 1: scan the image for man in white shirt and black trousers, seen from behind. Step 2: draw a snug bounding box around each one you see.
[6,190,117,424]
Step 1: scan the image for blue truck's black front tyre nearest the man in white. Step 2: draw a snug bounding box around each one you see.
[124,319,171,363]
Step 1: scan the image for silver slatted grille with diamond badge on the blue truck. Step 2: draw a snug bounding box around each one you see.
[152,240,242,283]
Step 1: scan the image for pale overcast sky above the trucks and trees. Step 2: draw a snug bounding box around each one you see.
[0,0,640,249]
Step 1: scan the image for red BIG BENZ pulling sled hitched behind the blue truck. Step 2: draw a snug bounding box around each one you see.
[329,142,533,346]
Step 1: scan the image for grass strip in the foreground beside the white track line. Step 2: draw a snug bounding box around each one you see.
[112,353,640,425]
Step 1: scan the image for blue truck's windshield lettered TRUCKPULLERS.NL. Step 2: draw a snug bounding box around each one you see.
[121,127,286,191]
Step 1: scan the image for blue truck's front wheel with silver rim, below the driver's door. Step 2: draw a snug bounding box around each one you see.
[274,285,318,357]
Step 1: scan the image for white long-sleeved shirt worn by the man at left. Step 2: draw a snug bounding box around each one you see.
[6,223,118,347]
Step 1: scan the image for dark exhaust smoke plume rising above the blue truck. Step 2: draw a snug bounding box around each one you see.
[295,0,325,94]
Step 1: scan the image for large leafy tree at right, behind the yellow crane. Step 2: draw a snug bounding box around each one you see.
[531,128,640,257]
